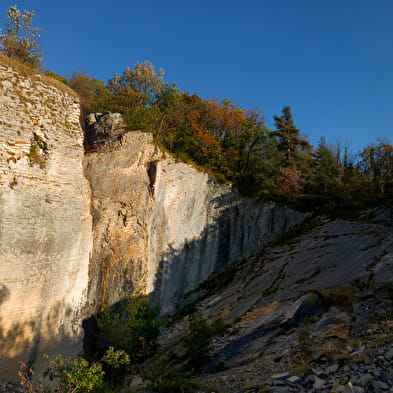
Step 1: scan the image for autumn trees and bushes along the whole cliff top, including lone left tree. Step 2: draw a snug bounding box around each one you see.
[0,6,393,210]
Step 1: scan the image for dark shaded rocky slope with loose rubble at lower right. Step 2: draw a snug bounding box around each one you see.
[152,209,393,393]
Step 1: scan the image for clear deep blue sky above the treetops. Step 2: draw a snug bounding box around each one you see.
[0,0,393,150]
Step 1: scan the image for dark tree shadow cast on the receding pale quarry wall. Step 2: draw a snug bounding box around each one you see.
[151,195,305,312]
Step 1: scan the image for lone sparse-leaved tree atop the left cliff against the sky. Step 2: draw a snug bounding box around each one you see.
[0,5,42,67]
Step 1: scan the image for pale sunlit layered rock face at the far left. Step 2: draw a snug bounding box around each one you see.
[0,58,92,378]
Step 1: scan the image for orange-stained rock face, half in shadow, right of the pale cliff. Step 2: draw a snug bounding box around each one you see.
[85,114,304,312]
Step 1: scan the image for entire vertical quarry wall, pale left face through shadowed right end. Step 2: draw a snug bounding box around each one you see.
[0,57,304,378]
